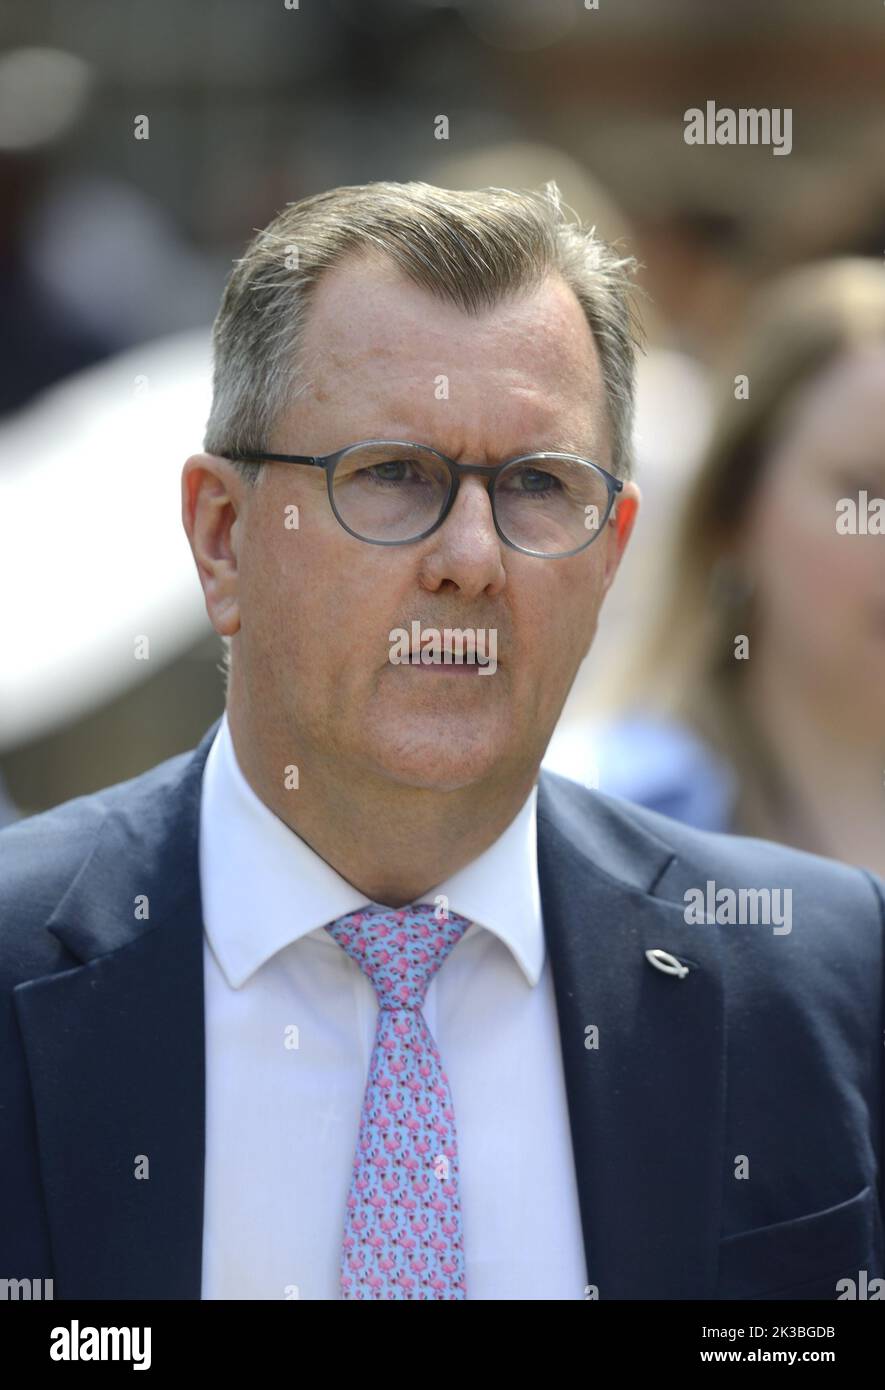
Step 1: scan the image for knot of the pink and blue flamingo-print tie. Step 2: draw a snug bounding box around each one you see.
[325,902,470,1009]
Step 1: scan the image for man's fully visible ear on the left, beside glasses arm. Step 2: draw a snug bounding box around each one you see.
[181,453,246,637]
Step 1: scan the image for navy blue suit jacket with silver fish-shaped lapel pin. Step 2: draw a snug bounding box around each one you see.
[0,724,885,1300]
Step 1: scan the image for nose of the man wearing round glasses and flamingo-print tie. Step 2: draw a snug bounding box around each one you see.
[421,477,506,596]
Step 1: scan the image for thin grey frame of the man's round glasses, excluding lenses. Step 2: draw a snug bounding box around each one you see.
[224,439,624,560]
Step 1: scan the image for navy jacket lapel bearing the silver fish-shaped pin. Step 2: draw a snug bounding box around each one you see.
[538,773,725,1300]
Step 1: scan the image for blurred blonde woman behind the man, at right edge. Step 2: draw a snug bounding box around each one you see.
[597,259,885,874]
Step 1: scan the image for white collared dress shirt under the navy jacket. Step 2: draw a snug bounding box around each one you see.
[200,716,588,1300]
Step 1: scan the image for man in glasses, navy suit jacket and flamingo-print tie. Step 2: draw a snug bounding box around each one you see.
[0,183,885,1300]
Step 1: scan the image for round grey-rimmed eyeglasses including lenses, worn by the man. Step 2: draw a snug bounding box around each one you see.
[226,439,624,559]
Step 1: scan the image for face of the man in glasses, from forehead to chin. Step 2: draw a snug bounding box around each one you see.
[210,259,638,791]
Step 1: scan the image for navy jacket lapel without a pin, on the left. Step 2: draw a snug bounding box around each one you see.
[15,723,218,1298]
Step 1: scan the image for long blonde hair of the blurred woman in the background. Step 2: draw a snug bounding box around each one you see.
[606,257,885,837]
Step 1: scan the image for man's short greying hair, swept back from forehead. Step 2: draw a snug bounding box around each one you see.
[203,181,642,482]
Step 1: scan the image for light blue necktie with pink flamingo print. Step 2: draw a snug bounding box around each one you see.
[326,902,470,1300]
